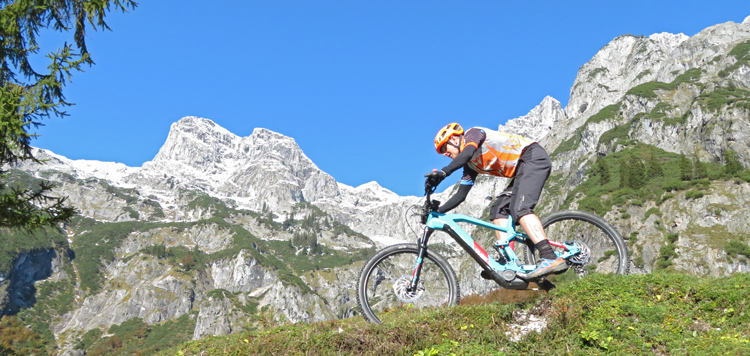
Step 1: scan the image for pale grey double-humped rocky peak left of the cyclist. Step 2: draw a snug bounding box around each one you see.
[140,117,338,210]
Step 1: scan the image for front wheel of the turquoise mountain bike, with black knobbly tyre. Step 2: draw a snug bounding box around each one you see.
[357,244,459,323]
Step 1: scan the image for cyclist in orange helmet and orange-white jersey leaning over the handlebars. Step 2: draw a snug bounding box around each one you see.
[425,122,568,279]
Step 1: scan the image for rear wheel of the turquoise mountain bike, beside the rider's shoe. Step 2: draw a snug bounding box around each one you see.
[516,210,630,283]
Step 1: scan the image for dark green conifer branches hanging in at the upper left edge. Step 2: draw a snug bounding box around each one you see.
[0,0,137,230]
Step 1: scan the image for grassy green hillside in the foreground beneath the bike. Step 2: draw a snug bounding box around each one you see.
[145,273,750,356]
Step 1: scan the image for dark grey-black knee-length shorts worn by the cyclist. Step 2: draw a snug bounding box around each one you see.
[490,143,552,223]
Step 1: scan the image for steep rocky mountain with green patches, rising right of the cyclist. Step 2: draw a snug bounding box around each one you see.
[541,17,750,276]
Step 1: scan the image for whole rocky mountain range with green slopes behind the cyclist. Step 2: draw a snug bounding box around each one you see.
[0,14,750,355]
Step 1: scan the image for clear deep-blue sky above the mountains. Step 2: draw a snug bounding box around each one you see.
[33,0,750,195]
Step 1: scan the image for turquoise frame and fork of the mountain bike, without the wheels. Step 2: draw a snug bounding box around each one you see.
[409,196,580,290]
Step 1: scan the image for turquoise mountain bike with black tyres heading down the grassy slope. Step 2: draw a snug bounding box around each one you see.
[357,189,630,323]
